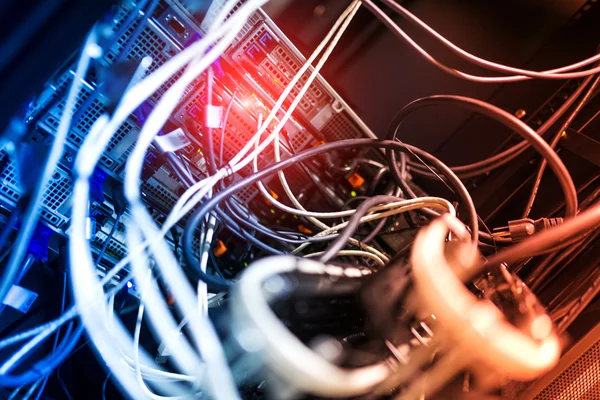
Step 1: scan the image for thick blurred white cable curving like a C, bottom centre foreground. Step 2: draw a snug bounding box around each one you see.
[231,256,390,398]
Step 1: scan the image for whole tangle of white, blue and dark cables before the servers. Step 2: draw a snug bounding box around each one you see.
[0,0,600,400]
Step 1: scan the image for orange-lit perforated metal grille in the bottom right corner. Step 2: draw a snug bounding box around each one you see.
[534,339,600,400]
